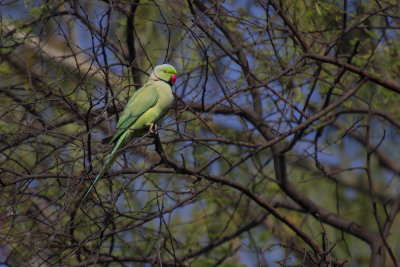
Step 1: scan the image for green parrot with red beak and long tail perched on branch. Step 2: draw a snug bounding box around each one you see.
[81,64,178,204]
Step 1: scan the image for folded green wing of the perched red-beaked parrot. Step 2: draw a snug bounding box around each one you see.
[110,83,158,144]
